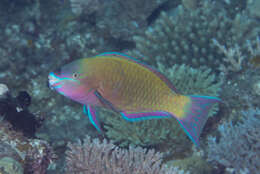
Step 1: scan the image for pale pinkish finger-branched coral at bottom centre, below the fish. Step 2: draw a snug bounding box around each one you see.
[66,136,189,174]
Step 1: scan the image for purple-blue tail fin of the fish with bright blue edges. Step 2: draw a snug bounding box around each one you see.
[177,95,221,146]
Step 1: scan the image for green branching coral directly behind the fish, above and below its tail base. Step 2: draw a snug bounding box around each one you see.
[101,64,221,156]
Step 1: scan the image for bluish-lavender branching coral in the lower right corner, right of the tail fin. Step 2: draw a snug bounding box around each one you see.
[207,108,260,174]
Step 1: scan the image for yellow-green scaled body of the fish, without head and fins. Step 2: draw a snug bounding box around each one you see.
[87,56,189,117]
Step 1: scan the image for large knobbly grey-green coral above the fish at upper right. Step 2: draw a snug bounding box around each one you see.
[130,0,260,70]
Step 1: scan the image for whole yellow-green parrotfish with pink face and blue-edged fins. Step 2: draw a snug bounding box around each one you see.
[48,52,221,147]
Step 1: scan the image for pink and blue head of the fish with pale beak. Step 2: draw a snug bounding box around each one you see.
[48,60,90,102]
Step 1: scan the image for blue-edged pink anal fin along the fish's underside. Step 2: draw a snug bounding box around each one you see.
[120,111,172,122]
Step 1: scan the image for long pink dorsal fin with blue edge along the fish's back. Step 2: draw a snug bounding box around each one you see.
[97,52,178,93]
